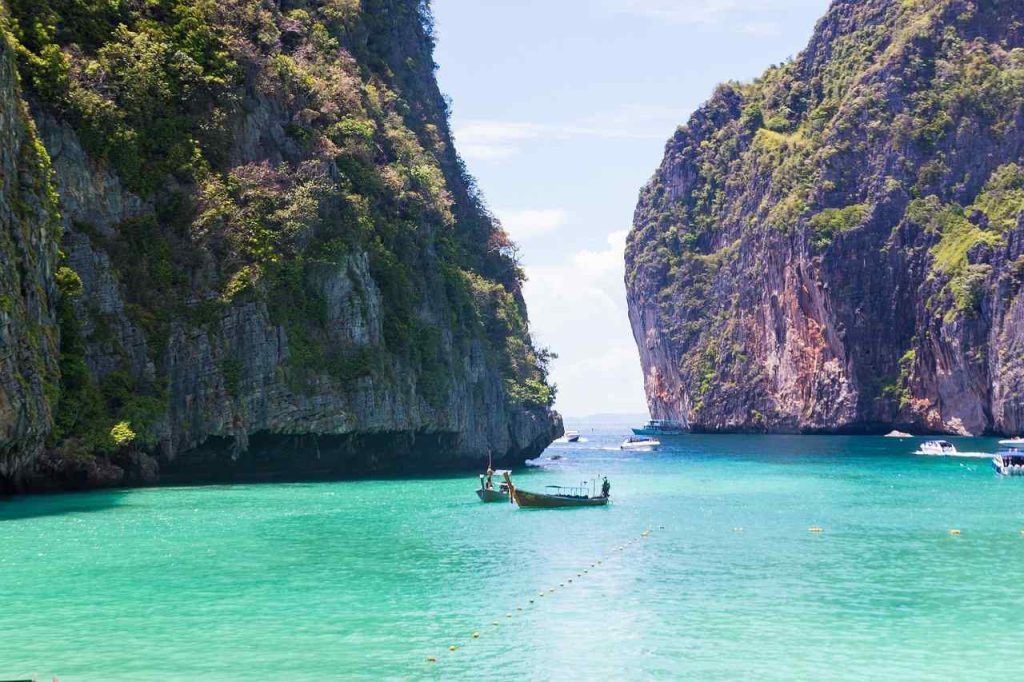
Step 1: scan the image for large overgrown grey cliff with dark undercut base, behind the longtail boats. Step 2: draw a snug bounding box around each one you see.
[0,0,561,487]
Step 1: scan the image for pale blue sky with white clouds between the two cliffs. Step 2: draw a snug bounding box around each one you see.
[433,0,827,417]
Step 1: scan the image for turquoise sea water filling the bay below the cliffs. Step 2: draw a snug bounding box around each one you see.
[0,427,1024,682]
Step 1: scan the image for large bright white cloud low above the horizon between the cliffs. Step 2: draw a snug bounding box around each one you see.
[525,230,646,415]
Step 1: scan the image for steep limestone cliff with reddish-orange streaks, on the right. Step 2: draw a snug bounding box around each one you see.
[626,0,1024,434]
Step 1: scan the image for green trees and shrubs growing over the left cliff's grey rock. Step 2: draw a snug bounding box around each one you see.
[3,0,554,483]
